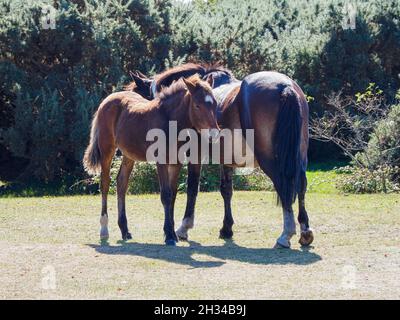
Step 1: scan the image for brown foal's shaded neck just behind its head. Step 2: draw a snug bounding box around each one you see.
[160,89,193,131]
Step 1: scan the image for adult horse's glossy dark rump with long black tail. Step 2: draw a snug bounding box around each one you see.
[238,72,308,207]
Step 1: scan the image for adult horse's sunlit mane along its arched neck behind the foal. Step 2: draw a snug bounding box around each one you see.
[124,63,233,91]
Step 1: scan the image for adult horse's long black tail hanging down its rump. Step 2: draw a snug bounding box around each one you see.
[274,86,301,208]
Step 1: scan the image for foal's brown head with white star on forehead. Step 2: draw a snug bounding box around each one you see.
[182,75,219,138]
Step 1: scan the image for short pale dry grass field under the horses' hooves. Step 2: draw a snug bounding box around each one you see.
[0,192,400,299]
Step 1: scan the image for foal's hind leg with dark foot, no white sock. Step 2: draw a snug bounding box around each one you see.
[117,156,135,240]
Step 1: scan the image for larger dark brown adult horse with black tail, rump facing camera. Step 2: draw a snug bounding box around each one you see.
[128,64,314,248]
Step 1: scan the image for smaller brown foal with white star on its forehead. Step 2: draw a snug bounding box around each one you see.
[83,76,218,245]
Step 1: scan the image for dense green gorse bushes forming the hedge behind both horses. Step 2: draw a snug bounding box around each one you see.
[0,0,400,192]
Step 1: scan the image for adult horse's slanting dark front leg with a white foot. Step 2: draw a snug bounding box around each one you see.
[176,163,201,240]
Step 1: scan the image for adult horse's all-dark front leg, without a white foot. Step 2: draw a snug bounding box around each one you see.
[219,166,234,239]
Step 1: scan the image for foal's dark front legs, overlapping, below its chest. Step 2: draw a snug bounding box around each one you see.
[157,164,182,246]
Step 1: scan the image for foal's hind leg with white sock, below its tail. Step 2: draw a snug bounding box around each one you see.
[100,150,113,240]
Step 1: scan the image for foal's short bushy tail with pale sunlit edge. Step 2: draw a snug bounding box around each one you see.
[83,112,100,175]
